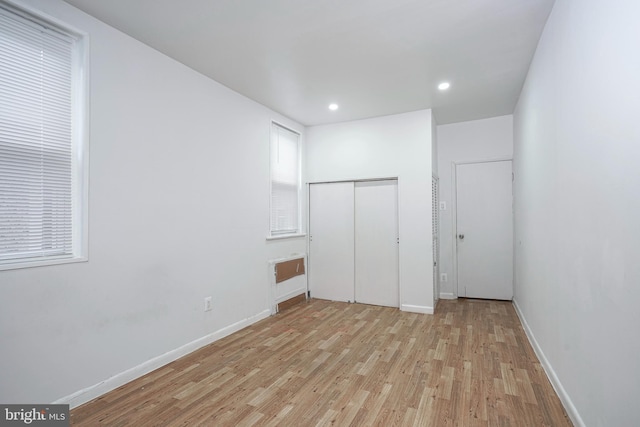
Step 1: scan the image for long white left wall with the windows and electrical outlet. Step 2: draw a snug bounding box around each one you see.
[0,0,306,404]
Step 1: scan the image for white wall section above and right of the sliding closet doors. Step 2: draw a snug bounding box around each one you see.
[307,110,433,312]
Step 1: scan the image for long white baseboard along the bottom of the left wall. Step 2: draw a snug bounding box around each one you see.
[52,310,271,409]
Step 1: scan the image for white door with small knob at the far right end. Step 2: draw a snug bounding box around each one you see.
[456,160,513,300]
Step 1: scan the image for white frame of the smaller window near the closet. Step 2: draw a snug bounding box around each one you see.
[267,120,304,240]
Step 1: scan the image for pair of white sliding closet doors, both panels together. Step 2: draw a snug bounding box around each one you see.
[309,180,399,307]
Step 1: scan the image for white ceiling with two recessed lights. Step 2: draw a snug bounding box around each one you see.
[65,0,554,126]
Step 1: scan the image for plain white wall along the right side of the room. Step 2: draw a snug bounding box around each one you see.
[514,0,640,426]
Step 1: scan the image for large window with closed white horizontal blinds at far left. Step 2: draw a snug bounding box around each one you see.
[0,4,87,269]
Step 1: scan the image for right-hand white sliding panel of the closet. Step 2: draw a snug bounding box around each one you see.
[355,180,399,307]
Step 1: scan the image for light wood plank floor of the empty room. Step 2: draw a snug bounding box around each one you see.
[71,299,571,427]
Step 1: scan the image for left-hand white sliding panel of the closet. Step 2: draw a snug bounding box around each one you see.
[309,182,355,301]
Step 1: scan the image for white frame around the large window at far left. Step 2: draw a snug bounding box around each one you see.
[0,1,89,271]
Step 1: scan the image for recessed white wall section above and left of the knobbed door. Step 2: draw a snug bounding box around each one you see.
[437,116,513,298]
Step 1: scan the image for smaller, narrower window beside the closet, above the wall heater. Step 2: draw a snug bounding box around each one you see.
[271,123,300,236]
